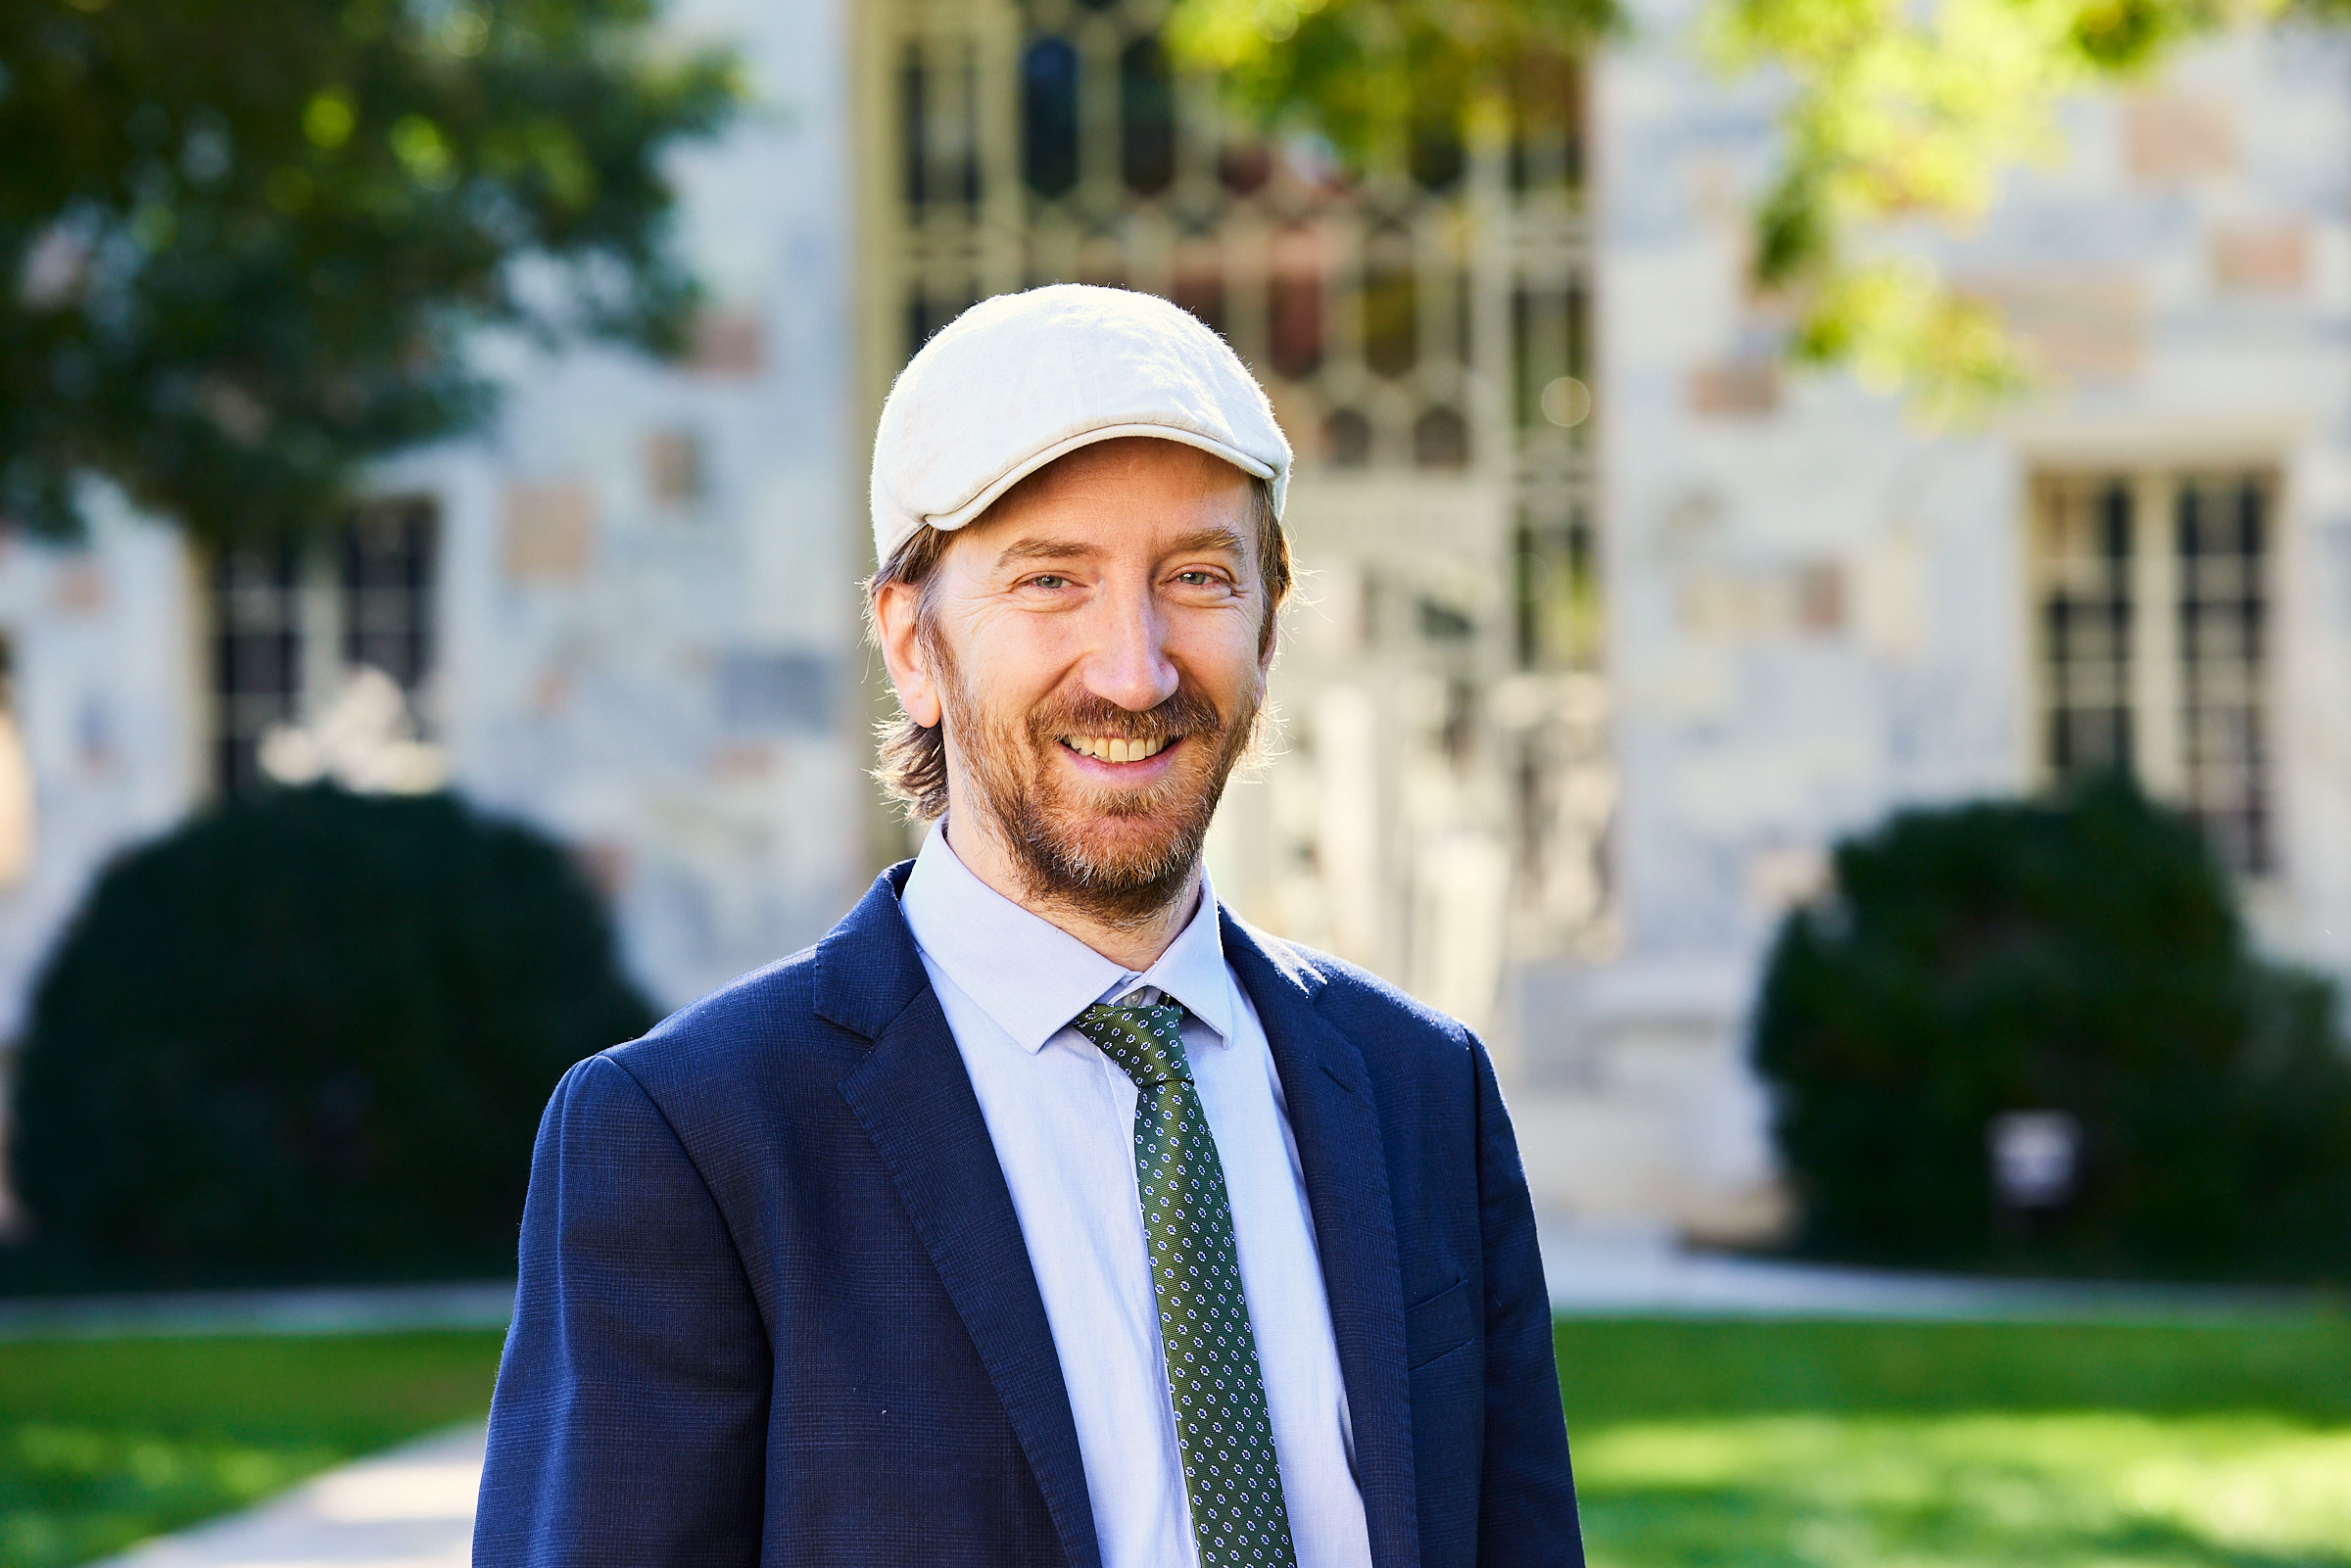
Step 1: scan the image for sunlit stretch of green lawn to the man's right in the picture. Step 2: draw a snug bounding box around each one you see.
[1559,1316,2351,1568]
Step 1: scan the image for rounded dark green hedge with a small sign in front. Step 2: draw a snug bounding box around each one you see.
[1753,778,2351,1279]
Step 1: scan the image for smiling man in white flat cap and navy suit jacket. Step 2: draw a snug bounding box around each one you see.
[475,287,1582,1568]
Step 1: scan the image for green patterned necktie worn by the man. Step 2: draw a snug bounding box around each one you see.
[1075,1002,1298,1568]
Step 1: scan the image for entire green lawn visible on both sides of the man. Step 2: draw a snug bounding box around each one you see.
[0,1316,2351,1568]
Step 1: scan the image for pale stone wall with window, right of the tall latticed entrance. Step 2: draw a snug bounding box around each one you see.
[1579,0,2351,1229]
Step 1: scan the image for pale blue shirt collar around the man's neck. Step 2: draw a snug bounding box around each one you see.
[898,821,1232,1056]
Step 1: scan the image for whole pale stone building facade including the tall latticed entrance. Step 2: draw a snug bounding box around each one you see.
[0,0,2351,1237]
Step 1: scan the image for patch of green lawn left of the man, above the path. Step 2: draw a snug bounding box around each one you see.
[0,1331,504,1568]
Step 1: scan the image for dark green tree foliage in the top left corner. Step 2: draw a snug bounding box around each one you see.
[0,0,739,541]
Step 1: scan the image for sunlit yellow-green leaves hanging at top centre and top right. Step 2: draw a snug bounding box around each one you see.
[1169,0,2344,416]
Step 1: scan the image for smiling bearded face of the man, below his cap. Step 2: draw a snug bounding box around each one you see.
[893,437,1270,924]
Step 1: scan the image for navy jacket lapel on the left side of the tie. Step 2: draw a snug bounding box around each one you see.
[816,865,1100,1568]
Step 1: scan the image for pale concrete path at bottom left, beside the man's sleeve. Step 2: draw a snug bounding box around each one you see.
[104,1425,482,1568]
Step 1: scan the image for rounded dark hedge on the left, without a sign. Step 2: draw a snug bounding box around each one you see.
[7,785,653,1286]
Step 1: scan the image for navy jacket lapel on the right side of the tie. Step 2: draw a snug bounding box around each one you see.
[1221,910,1420,1568]
